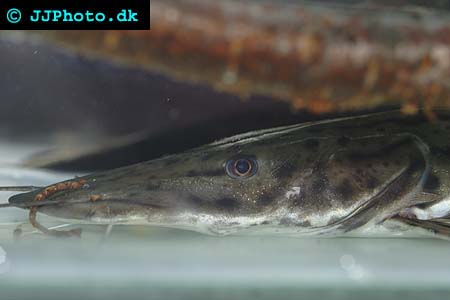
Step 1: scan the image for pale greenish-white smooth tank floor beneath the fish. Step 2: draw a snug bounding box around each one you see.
[0,226,450,299]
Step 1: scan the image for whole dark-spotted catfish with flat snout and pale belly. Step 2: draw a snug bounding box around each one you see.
[3,111,450,238]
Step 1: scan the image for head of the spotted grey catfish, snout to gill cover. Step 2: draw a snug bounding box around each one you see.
[10,123,426,234]
